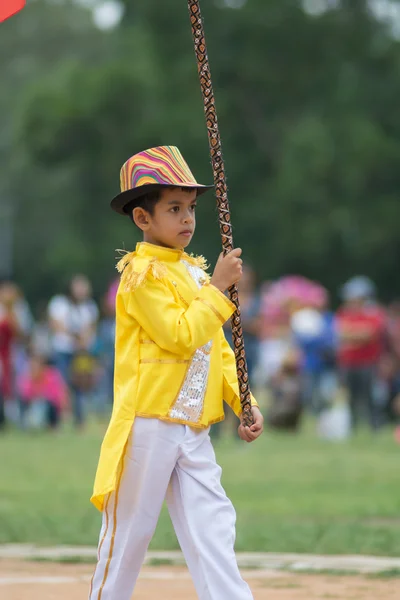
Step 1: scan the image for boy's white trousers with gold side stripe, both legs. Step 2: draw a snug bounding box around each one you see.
[89,418,253,600]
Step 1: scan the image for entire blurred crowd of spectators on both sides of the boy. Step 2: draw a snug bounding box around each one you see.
[0,266,400,438]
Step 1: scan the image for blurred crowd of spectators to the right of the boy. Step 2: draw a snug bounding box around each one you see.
[227,266,400,439]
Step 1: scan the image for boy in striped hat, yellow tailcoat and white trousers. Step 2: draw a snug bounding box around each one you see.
[90,146,263,600]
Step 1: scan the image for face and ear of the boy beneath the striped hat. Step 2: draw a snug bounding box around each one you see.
[133,188,197,248]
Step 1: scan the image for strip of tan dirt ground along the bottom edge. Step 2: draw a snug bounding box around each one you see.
[0,560,399,600]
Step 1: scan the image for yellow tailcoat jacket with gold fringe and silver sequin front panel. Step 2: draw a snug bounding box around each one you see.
[91,243,256,510]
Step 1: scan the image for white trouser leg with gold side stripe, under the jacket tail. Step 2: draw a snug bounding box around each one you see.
[89,418,185,600]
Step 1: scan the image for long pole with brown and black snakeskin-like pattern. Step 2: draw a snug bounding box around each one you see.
[188,0,253,426]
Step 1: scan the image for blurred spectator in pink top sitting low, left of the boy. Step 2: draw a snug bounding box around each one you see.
[17,354,68,429]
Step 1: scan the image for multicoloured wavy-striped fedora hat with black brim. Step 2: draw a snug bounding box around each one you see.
[111,146,214,215]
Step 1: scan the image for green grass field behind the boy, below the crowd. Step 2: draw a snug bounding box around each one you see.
[0,424,400,556]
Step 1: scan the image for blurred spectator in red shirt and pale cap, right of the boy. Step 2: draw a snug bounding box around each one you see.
[336,277,386,429]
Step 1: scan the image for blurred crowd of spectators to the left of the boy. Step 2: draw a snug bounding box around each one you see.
[0,275,118,429]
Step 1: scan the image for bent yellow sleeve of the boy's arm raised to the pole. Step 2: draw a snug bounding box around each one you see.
[124,278,235,355]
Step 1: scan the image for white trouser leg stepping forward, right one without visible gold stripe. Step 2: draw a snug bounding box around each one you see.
[167,427,253,600]
